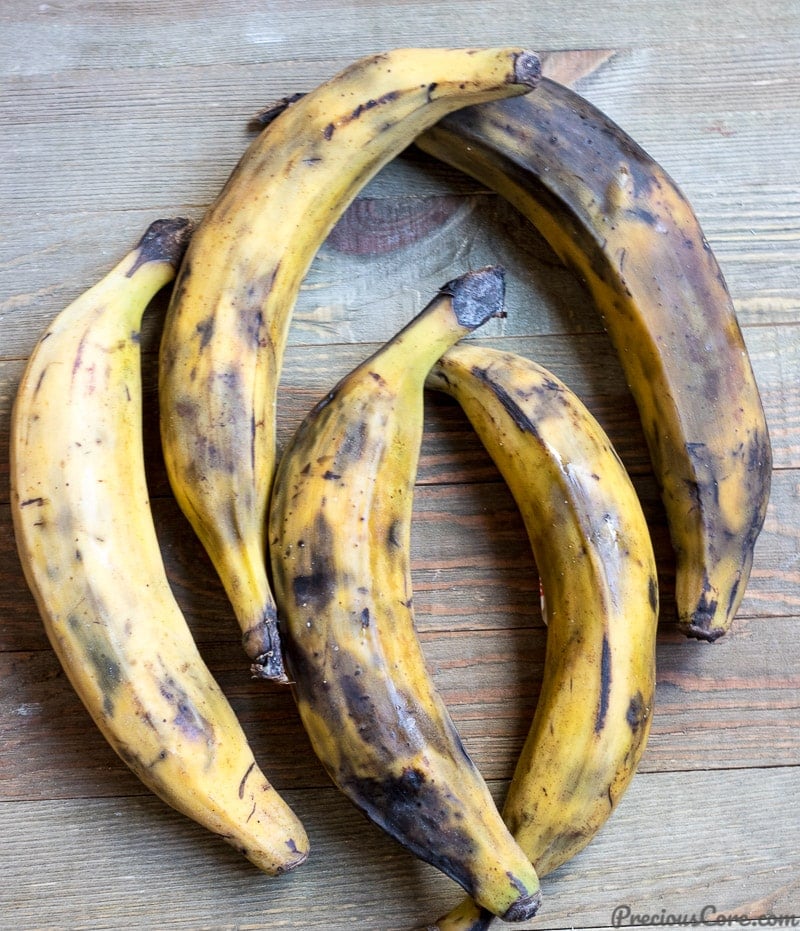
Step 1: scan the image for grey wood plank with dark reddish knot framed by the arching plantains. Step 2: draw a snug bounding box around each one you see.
[0,180,800,359]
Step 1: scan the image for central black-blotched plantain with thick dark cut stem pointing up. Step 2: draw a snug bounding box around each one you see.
[269,269,539,921]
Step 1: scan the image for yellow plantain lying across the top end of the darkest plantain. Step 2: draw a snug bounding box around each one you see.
[159,48,539,682]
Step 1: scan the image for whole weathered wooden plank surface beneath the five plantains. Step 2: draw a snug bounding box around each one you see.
[0,0,800,931]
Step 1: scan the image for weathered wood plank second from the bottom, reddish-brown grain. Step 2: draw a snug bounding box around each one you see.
[0,598,800,799]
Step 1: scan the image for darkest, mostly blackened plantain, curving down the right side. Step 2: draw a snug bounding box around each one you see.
[417,79,771,641]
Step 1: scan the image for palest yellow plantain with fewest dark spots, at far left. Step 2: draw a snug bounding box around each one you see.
[11,219,307,874]
